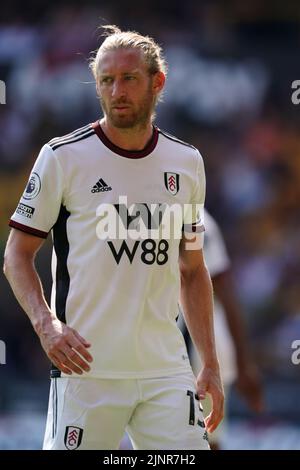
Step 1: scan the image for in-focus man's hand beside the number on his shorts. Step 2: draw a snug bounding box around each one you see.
[196,367,224,433]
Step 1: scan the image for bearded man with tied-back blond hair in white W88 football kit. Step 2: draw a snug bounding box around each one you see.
[5,26,223,449]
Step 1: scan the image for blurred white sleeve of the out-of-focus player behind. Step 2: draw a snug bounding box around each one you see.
[204,211,230,277]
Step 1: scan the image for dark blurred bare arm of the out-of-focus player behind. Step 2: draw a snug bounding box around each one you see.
[212,270,263,411]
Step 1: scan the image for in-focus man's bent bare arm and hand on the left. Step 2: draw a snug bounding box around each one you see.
[4,229,92,374]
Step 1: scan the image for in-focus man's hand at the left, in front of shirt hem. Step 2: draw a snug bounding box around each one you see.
[38,315,93,375]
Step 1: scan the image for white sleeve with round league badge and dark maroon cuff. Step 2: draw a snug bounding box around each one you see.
[9,145,64,238]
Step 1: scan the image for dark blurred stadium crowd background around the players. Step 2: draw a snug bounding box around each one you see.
[0,0,300,449]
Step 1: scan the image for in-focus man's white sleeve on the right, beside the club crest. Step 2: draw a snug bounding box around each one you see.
[183,150,206,233]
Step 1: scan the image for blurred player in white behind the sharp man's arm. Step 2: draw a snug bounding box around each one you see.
[179,210,263,449]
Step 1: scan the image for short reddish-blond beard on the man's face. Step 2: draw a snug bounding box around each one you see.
[100,86,156,129]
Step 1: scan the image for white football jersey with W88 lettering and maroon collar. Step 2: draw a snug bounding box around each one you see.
[10,122,205,378]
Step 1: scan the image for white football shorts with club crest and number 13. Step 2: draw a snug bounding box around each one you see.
[43,374,209,450]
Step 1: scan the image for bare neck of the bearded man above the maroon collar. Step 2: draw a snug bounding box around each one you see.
[100,117,153,150]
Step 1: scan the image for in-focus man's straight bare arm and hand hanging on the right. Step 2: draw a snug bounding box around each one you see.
[179,235,224,432]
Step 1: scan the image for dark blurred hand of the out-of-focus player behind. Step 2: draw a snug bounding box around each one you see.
[236,360,264,413]
